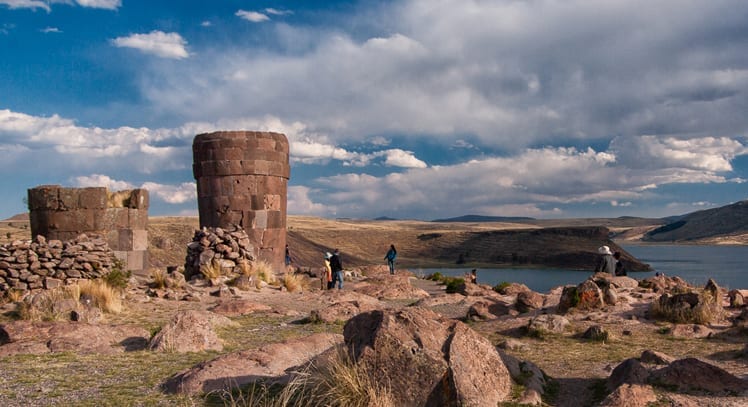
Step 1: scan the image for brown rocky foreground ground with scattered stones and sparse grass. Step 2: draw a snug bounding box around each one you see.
[0,267,748,406]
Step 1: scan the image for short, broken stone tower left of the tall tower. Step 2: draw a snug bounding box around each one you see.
[28,185,148,272]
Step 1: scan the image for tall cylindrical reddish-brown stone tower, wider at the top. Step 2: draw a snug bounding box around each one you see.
[192,131,290,270]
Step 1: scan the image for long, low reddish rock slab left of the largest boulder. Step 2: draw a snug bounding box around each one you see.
[161,333,343,394]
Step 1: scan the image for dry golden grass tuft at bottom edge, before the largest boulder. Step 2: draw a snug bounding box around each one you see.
[219,348,395,407]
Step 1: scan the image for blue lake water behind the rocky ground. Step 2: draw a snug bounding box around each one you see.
[418,245,748,293]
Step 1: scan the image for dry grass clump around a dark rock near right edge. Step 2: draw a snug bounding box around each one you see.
[649,290,725,324]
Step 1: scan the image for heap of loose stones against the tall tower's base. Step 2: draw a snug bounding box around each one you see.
[184,227,255,279]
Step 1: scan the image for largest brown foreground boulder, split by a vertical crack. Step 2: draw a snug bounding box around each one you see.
[343,307,511,406]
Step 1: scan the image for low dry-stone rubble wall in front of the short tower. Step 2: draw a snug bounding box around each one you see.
[0,235,114,292]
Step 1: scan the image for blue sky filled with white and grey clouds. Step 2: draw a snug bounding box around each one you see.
[0,0,748,220]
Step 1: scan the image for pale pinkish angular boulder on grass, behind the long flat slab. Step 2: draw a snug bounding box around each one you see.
[148,310,234,352]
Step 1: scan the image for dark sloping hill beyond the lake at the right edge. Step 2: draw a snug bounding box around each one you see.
[643,200,748,242]
